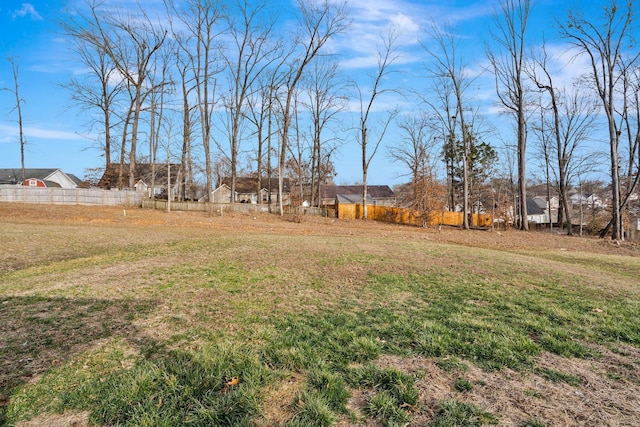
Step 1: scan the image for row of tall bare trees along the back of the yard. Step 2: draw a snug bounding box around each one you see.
[57,0,640,239]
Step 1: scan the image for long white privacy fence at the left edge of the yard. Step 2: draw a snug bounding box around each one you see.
[0,185,145,205]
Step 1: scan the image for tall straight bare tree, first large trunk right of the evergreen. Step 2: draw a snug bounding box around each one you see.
[487,0,531,231]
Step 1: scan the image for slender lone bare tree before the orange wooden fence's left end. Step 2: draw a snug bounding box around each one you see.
[356,28,399,219]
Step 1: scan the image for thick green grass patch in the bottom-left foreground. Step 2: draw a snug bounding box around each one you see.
[7,345,273,426]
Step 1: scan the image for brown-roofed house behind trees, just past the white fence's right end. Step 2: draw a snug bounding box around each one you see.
[98,163,181,198]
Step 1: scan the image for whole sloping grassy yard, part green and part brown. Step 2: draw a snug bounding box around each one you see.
[0,204,640,427]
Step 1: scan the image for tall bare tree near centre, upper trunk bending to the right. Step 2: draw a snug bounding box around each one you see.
[278,0,347,215]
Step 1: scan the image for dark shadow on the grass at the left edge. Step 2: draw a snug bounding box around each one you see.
[0,296,154,412]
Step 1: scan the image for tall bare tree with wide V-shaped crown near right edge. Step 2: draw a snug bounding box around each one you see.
[560,0,640,240]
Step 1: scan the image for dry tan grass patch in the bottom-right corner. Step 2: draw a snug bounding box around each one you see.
[370,347,640,427]
